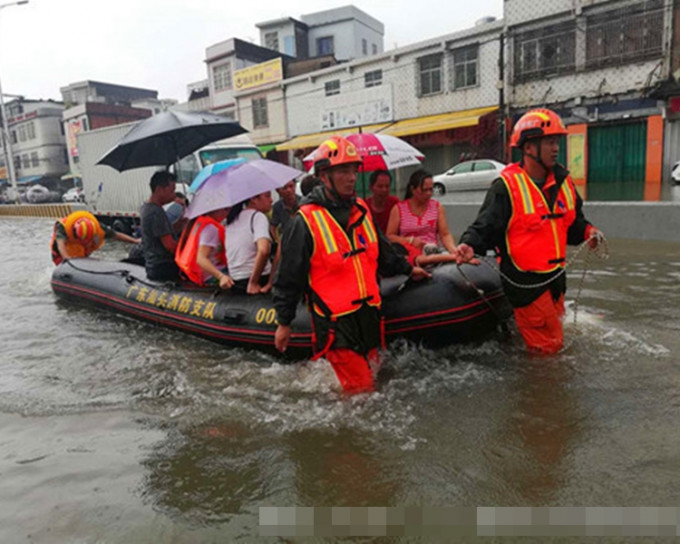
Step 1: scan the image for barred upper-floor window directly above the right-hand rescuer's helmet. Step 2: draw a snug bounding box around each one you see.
[513,22,576,83]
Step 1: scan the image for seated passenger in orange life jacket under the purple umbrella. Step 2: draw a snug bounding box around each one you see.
[175,208,234,289]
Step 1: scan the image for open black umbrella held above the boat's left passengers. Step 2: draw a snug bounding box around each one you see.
[97,111,247,172]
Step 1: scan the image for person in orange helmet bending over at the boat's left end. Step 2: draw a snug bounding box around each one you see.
[50,211,139,265]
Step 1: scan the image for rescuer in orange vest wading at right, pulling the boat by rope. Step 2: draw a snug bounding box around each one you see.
[458,109,603,353]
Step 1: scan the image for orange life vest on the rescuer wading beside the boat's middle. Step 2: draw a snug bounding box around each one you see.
[298,199,380,319]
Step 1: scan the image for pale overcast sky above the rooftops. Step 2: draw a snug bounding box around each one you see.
[0,0,503,101]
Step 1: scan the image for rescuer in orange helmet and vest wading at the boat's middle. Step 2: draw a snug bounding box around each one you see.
[273,136,429,393]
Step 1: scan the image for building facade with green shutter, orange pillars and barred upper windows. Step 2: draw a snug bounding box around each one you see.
[504,0,668,200]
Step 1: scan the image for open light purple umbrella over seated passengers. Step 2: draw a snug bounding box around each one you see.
[184,159,302,219]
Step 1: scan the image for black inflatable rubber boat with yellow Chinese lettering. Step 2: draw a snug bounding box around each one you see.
[52,258,512,358]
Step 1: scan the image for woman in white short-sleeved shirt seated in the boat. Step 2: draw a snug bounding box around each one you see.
[226,191,276,295]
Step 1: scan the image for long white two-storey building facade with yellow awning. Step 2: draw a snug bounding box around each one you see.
[277,20,503,190]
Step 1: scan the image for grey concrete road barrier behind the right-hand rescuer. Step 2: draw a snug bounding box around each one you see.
[442,201,680,242]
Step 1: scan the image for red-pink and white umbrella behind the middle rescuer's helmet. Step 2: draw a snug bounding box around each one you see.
[303,132,425,172]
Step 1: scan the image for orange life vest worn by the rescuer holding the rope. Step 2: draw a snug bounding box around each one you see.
[501,163,577,273]
